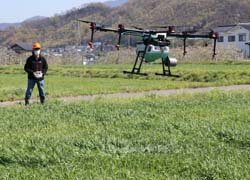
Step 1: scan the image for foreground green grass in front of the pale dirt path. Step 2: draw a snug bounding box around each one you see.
[0,92,250,179]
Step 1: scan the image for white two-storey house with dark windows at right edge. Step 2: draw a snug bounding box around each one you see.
[214,23,250,58]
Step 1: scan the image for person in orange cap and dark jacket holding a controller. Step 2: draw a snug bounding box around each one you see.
[24,43,48,105]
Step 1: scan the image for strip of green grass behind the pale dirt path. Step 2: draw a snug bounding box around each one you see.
[0,62,250,101]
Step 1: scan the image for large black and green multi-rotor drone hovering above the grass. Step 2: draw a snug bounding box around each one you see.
[77,19,218,76]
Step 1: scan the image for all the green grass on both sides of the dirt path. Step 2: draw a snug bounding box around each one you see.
[0,62,250,179]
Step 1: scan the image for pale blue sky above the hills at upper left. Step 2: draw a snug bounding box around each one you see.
[0,0,107,23]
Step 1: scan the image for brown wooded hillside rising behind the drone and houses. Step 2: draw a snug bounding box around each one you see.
[0,0,250,46]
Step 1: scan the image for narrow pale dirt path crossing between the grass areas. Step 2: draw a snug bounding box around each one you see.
[0,84,250,107]
